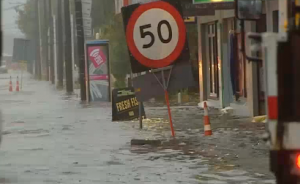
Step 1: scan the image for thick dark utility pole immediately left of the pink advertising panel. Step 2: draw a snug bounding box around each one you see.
[75,0,87,101]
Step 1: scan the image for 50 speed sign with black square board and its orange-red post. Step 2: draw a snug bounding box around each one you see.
[122,0,189,137]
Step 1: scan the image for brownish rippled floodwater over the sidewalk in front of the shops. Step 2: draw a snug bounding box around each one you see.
[126,106,274,182]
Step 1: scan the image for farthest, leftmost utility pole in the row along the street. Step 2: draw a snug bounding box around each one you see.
[34,0,42,80]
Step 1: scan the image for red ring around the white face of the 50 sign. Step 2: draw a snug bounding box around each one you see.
[126,1,186,68]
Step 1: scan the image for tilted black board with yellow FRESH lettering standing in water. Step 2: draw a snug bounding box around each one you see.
[112,88,145,121]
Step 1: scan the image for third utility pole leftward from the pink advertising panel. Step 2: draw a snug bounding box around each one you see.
[56,0,64,89]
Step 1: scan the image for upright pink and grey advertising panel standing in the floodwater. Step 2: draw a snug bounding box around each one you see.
[86,41,110,102]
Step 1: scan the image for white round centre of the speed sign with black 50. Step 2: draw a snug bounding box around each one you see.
[133,8,179,60]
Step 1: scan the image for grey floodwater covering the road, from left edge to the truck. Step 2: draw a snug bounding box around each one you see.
[0,73,274,184]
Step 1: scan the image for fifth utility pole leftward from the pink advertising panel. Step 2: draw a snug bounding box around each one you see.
[42,0,49,81]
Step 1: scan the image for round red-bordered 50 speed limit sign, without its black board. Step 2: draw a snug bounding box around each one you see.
[126,1,186,68]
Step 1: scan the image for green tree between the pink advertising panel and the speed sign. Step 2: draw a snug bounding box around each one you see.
[91,0,130,87]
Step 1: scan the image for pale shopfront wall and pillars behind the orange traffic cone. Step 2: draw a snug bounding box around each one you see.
[198,10,258,116]
